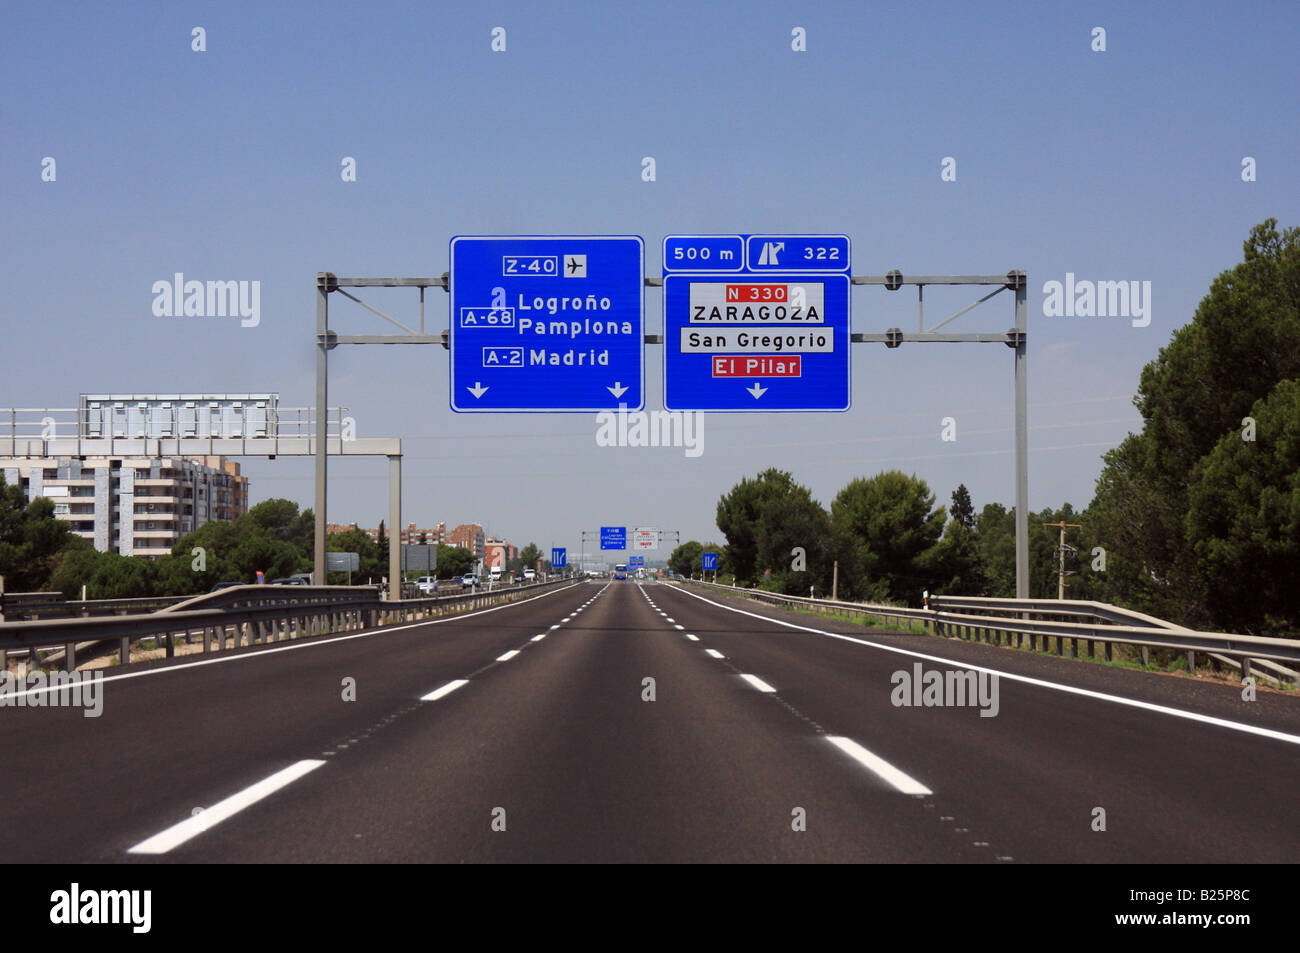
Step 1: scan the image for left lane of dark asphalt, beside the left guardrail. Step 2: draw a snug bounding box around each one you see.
[0,585,594,862]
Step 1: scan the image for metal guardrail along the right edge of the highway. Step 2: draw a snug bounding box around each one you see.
[683,580,1300,677]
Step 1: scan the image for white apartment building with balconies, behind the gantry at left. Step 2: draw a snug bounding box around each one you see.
[0,456,248,559]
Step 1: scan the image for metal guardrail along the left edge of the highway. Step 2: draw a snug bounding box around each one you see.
[0,580,575,671]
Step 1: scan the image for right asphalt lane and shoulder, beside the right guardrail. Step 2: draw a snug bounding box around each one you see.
[654,586,1300,863]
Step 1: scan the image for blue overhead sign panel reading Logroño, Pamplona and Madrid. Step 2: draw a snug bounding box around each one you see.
[449,235,645,413]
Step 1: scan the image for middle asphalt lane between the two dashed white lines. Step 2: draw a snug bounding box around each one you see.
[137,584,982,862]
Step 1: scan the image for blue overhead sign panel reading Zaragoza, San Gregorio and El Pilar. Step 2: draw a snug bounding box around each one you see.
[663,235,852,412]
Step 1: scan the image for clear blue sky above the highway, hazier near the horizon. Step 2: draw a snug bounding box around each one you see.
[0,0,1300,556]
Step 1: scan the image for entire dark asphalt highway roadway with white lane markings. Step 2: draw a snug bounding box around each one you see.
[0,580,1300,865]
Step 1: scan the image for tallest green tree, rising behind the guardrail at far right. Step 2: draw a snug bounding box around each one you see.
[1089,218,1300,628]
